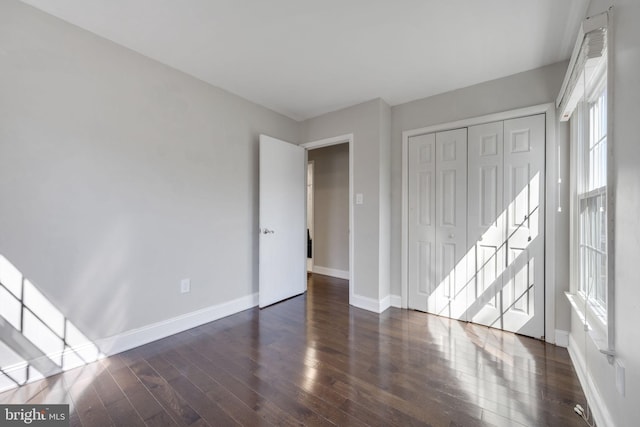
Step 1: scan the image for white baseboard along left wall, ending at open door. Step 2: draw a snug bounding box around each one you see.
[0,293,258,393]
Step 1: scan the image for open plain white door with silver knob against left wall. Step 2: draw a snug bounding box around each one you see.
[258,135,307,308]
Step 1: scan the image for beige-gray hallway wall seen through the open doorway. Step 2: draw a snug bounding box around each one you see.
[309,144,349,272]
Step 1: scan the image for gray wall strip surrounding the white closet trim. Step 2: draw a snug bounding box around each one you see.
[391,62,570,330]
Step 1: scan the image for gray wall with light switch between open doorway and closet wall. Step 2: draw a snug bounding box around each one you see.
[300,99,390,302]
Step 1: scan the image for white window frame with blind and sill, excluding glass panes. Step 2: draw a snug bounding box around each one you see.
[556,12,615,363]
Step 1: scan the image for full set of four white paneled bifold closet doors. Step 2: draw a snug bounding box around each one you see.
[407,114,545,338]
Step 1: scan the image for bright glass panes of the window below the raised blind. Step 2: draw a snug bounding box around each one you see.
[572,80,607,323]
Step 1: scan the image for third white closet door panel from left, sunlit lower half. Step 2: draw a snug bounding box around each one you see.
[467,122,506,328]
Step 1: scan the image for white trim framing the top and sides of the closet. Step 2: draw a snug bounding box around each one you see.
[400,102,558,343]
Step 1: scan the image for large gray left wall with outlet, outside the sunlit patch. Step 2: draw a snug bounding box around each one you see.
[0,0,299,346]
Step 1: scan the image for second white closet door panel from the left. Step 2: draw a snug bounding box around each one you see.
[427,128,467,320]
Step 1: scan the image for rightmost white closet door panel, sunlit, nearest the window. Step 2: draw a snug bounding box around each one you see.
[502,114,545,338]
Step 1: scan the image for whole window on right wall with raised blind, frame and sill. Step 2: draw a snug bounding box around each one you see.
[556,12,615,363]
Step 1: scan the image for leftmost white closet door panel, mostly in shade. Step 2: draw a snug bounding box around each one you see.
[407,134,436,311]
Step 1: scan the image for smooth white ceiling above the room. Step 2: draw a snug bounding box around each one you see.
[23,0,589,120]
